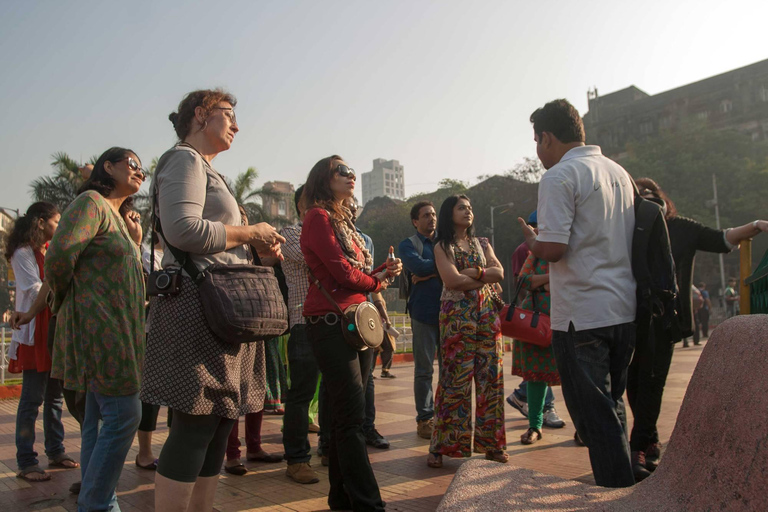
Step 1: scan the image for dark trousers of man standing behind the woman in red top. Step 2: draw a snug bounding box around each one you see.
[283,324,320,464]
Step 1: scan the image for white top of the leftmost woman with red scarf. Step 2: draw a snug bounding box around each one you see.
[8,245,43,359]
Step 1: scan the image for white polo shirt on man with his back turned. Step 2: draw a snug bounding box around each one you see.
[538,146,637,331]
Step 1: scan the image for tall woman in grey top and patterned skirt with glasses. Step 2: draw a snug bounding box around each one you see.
[141,90,285,512]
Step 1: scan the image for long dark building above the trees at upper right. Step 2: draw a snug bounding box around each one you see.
[584,60,768,159]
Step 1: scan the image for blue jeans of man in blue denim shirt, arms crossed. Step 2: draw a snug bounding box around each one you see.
[411,317,442,421]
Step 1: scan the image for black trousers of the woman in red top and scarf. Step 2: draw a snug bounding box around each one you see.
[307,321,384,512]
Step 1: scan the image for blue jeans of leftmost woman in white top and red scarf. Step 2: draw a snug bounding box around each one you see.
[16,370,64,470]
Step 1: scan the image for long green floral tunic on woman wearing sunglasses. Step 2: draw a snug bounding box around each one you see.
[45,190,145,396]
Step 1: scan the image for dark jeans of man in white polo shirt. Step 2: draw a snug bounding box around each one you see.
[552,323,635,487]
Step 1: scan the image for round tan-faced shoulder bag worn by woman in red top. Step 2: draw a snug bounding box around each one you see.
[307,269,384,352]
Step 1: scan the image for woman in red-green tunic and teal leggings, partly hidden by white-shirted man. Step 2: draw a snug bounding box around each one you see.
[512,254,560,444]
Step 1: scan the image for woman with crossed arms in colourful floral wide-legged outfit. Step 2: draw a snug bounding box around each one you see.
[427,195,508,468]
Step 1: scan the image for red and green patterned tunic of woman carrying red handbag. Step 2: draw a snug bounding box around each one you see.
[512,254,560,386]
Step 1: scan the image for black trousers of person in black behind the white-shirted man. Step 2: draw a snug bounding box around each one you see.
[627,322,674,452]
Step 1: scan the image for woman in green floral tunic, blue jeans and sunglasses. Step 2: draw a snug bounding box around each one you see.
[45,148,145,510]
